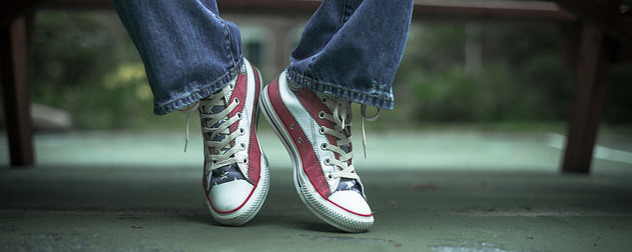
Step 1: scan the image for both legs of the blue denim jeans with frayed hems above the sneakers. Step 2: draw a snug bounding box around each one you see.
[114,0,413,115]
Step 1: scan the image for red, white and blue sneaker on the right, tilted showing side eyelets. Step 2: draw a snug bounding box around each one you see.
[261,73,373,232]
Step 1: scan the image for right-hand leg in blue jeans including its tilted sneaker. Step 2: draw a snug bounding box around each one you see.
[261,0,412,232]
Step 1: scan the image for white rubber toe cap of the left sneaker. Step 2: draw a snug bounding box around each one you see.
[209,180,254,213]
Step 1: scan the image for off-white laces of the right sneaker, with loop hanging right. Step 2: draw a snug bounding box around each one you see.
[318,96,380,179]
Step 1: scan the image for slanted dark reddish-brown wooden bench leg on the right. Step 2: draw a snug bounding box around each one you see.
[562,24,610,173]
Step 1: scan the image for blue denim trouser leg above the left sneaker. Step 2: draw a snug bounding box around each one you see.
[114,0,243,115]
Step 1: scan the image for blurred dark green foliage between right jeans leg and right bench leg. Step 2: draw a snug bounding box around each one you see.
[394,24,573,126]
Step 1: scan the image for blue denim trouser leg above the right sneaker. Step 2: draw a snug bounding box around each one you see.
[287,0,413,109]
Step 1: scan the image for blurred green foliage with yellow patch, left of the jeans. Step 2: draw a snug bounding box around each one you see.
[30,11,160,129]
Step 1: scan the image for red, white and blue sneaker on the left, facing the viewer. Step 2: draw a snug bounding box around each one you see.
[198,60,270,226]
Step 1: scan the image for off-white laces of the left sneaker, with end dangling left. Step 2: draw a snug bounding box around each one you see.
[180,85,247,172]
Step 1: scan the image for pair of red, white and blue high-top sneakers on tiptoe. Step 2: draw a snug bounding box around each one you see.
[197,60,373,232]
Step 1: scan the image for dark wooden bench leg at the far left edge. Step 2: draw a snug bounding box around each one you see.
[0,18,34,166]
